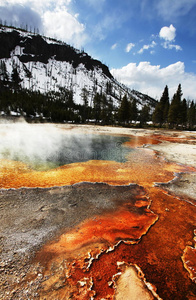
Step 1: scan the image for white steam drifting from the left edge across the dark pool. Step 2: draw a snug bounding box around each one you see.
[0,122,132,169]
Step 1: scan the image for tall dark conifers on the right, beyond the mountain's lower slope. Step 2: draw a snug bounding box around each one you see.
[118,84,196,129]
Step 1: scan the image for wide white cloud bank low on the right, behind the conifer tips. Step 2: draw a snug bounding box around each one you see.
[111,61,196,99]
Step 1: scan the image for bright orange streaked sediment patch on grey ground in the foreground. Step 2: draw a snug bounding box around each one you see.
[36,201,157,261]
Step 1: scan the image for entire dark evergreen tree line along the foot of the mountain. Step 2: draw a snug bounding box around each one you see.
[0,73,196,129]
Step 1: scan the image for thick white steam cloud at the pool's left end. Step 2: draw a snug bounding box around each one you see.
[0,123,62,168]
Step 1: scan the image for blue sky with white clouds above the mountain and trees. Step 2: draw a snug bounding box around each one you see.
[0,0,196,100]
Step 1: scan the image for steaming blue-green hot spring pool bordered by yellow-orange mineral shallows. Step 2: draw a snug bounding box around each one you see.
[1,134,133,171]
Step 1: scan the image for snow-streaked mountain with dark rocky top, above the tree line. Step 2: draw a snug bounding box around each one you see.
[0,25,157,122]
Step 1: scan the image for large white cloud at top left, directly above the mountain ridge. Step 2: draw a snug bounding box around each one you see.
[0,0,88,47]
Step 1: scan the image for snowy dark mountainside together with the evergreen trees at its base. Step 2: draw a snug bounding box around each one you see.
[0,25,196,129]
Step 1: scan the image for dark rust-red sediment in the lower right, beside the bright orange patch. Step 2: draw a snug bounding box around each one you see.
[33,188,196,300]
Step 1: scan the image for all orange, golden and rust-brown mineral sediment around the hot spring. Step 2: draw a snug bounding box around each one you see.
[1,129,196,300]
